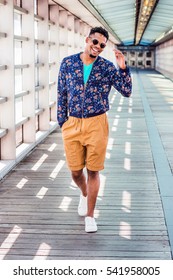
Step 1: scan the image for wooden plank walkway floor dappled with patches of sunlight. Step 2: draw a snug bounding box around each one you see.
[0,72,173,260]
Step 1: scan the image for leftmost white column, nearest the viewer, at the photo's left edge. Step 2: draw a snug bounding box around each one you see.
[0,1,16,160]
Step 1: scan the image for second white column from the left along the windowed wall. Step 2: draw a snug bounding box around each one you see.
[22,0,36,143]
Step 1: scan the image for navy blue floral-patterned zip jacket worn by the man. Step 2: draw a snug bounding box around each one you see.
[57,53,132,127]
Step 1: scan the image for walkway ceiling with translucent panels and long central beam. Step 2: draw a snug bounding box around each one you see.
[49,0,173,46]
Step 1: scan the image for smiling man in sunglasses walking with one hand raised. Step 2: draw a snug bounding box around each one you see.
[58,27,132,232]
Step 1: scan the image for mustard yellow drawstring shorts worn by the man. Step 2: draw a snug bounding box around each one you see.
[62,113,109,171]
